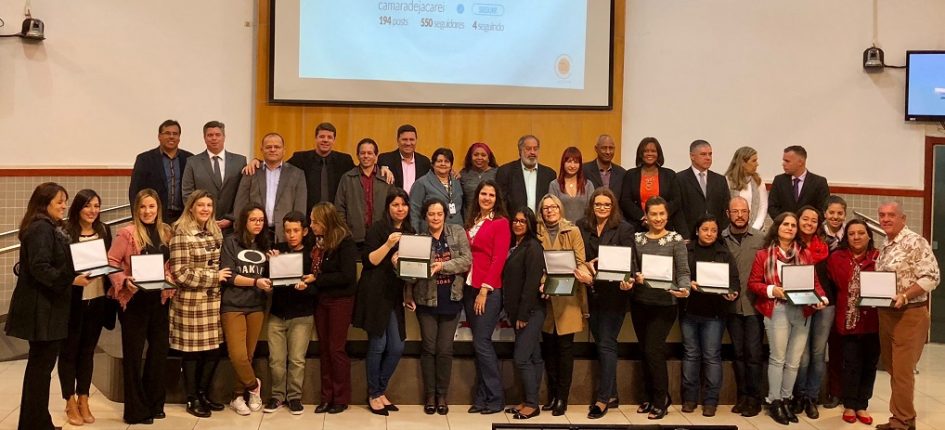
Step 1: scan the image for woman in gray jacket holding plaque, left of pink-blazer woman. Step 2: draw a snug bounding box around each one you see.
[404,198,470,415]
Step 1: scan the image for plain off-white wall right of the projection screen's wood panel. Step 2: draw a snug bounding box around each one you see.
[622,0,945,189]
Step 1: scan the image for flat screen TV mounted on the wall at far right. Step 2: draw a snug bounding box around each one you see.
[906,51,945,121]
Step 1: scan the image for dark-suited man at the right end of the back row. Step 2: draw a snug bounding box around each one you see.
[768,145,830,219]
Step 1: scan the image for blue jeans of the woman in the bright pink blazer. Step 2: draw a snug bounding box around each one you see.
[463,287,505,410]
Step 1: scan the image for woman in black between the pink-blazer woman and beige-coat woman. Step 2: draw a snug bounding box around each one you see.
[502,207,545,420]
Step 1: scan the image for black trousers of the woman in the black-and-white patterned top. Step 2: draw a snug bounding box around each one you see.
[630,302,677,407]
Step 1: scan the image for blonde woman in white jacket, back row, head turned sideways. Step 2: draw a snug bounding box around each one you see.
[725,146,768,230]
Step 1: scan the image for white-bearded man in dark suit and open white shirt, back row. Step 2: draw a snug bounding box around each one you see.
[495,134,557,216]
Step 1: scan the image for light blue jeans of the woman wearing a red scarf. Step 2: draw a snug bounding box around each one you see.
[765,303,810,402]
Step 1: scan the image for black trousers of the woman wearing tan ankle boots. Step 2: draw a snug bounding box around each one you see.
[57,294,111,399]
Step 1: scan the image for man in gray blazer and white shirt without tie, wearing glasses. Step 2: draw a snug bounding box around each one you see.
[233,133,308,242]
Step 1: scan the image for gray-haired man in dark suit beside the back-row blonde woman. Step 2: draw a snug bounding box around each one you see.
[676,139,730,239]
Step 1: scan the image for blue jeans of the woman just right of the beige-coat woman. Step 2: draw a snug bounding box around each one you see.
[588,310,627,403]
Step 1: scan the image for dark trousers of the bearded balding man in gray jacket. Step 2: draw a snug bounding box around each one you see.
[727,314,765,400]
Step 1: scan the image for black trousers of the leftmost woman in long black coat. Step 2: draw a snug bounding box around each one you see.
[17,340,62,430]
